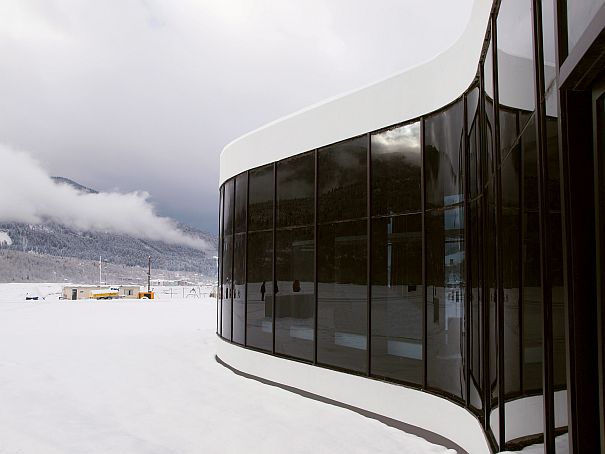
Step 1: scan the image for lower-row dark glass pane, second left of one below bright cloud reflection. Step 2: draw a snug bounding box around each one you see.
[275,227,315,361]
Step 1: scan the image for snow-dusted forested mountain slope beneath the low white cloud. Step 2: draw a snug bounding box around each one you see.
[0,177,217,281]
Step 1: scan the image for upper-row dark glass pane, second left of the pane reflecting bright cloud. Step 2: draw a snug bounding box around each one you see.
[276,152,315,228]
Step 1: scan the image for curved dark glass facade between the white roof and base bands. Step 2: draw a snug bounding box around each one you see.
[217,0,599,452]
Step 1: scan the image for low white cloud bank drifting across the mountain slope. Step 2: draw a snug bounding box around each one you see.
[0,144,208,249]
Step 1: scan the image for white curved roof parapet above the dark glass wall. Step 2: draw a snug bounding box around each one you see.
[219,0,492,185]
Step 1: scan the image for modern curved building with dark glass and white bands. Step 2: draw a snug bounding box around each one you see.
[217,0,605,453]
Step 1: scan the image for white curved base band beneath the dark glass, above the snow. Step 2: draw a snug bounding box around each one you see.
[216,336,491,454]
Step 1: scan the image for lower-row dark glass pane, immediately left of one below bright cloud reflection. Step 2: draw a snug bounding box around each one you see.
[317,221,368,372]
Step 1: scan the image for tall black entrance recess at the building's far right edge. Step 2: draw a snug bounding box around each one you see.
[557,1,605,446]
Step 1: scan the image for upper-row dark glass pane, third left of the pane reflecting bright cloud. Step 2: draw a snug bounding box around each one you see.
[248,164,274,230]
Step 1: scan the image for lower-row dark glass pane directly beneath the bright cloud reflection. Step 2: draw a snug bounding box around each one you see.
[371,214,424,383]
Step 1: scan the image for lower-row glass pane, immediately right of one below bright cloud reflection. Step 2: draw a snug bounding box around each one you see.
[425,207,465,399]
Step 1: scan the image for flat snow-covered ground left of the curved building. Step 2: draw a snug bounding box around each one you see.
[0,284,453,454]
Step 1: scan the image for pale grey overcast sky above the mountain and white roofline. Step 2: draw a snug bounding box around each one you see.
[0,0,472,233]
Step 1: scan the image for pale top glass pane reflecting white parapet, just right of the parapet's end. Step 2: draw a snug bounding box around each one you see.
[497,0,535,120]
